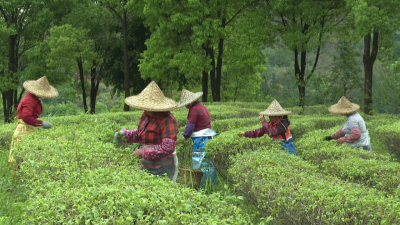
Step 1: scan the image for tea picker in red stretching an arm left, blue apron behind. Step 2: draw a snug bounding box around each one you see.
[238,99,296,155]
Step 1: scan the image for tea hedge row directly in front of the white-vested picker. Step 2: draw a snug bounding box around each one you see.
[296,127,400,193]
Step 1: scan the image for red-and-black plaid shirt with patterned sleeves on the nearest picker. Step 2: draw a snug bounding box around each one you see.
[122,112,179,169]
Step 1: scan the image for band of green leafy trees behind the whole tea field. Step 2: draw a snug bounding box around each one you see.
[0,0,400,122]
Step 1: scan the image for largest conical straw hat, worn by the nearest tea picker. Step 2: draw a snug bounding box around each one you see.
[125,81,178,112]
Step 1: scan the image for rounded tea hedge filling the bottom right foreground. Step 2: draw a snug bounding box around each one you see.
[229,148,400,224]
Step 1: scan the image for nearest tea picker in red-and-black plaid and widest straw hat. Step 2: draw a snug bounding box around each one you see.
[114,81,179,183]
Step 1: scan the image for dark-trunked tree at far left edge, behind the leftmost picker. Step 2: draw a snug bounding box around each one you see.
[0,0,70,122]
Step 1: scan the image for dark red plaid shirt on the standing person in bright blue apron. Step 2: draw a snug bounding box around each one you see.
[188,101,211,132]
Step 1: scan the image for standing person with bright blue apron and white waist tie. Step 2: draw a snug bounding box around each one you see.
[178,89,218,189]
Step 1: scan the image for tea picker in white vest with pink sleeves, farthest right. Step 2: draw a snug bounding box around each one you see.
[324,96,372,151]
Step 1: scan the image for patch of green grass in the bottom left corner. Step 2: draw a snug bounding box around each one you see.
[0,148,28,224]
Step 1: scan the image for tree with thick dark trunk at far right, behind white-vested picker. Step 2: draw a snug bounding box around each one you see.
[346,0,400,114]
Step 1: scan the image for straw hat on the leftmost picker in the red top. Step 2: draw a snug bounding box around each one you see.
[23,76,58,98]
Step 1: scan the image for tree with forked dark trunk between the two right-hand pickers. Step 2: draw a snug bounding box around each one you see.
[259,0,348,107]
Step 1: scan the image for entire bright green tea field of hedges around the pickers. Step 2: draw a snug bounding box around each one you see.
[0,102,400,224]
